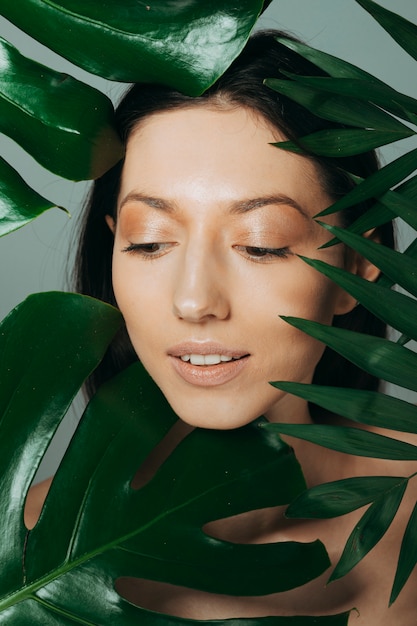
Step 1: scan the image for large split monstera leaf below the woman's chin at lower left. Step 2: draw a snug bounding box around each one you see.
[0,293,348,626]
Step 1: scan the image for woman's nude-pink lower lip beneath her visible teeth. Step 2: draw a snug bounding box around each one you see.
[171,356,249,387]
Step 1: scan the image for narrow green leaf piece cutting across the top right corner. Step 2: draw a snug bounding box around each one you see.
[356,0,417,61]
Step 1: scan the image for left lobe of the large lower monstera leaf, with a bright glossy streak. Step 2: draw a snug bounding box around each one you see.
[0,293,122,595]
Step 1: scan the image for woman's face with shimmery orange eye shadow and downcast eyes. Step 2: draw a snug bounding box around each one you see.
[108,107,354,428]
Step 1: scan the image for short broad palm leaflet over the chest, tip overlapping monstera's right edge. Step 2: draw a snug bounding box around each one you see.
[285,476,406,519]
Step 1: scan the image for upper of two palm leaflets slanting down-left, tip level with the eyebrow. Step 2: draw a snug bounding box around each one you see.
[316,148,417,217]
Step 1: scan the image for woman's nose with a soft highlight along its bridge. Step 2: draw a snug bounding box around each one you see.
[173,248,230,323]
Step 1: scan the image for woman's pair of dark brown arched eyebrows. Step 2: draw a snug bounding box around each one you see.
[119,191,310,220]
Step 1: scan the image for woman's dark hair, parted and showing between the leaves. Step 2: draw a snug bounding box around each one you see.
[75,30,394,410]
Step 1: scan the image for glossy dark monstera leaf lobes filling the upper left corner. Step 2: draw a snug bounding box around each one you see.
[0,0,269,234]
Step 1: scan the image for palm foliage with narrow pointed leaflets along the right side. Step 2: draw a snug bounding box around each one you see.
[266,0,417,603]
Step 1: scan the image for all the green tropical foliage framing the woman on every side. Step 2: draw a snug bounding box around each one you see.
[0,0,417,626]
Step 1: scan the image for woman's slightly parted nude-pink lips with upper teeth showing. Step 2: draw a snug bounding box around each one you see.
[168,344,250,387]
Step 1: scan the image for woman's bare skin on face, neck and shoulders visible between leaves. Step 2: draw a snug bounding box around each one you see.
[26,105,417,626]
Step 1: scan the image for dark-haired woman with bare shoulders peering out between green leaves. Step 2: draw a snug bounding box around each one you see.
[28,32,416,626]
